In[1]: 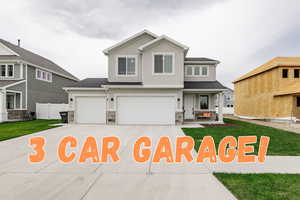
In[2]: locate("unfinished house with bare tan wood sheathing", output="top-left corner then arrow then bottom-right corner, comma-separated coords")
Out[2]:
233,57 -> 300,120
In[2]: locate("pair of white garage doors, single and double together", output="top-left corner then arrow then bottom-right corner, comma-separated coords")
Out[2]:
74,94 -> 177,125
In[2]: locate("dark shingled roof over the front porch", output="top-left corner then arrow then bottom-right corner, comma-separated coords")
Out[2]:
184,81 -> 227,89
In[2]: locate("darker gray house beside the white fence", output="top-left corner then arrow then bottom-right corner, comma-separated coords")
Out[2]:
0,39 -> 78,122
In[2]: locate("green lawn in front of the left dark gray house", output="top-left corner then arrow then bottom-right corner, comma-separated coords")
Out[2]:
0,120 -> 60,141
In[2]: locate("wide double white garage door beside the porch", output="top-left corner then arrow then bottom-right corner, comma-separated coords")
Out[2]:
117,96 -> 176,124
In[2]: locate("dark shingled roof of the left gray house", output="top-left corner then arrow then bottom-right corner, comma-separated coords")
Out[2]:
0,39 -> 78,80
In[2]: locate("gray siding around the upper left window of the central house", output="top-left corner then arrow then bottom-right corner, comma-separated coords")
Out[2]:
108,34 -> 153,82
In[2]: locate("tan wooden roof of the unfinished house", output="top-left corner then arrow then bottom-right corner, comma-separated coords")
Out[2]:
233,57 -> 300,83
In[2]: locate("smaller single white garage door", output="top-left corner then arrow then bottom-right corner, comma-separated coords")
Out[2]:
75,97 -> 106,124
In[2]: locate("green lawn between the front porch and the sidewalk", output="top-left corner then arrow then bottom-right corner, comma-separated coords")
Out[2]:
183,119 -> 300,156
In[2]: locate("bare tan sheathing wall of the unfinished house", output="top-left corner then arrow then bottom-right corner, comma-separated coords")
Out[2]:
234,67 -> 299,118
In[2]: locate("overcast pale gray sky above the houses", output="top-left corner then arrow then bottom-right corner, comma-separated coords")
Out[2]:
0,0 -> 300,87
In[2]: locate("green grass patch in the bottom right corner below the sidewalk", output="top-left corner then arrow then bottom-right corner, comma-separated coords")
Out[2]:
214,173 -> 300,200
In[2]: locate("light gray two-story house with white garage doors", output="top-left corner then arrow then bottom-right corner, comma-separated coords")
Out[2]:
65,30 -> 226,125
